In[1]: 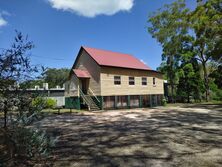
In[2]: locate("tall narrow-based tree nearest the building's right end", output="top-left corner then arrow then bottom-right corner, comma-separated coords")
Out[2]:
148,0 -> 189,101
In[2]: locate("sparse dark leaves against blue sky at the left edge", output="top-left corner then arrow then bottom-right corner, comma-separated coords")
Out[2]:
0,31 -> 38,89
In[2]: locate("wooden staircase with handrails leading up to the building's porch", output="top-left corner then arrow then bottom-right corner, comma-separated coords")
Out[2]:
79,89 -> 100,111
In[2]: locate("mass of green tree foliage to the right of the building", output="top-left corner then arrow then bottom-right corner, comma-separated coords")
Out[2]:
148,0 -> 222,101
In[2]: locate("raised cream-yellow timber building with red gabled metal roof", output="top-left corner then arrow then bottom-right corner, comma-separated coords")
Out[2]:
65,47 -> 164,110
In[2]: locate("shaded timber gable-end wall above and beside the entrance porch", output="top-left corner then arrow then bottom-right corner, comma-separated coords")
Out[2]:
75,50 -> 101,95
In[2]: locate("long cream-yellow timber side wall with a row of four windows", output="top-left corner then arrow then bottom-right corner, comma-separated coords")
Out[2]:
100,67 -> 164,96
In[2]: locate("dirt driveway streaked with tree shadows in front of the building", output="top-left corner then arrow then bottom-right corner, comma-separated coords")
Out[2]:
36,105 -> 222,167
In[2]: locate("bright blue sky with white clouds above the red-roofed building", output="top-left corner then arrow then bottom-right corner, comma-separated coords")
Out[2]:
0,0 -> 195,70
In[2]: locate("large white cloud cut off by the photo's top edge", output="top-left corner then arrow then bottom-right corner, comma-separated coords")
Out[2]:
48,0 -> 134,17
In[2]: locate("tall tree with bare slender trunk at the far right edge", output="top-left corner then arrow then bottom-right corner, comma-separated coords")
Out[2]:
187,0 -> 222,101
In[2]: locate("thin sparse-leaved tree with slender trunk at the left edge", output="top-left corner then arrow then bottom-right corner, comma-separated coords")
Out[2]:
0,31 -> 38,127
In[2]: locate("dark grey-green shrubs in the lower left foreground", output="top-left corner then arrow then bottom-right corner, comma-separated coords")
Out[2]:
0,95 -> 55,166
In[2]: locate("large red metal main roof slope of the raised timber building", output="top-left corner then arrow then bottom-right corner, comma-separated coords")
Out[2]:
83,47 -> 152,70
